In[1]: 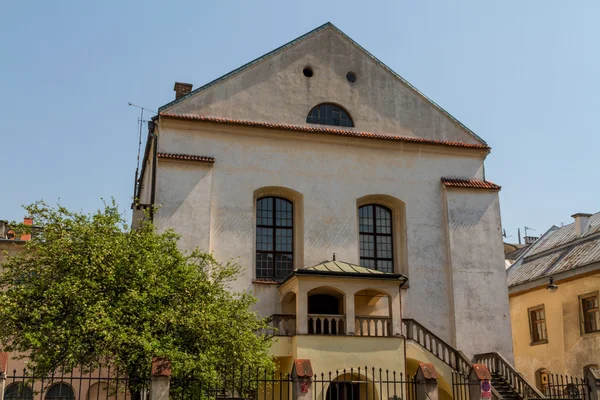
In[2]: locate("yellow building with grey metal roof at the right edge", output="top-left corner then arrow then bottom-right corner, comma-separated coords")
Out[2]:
507,213 -> 600,391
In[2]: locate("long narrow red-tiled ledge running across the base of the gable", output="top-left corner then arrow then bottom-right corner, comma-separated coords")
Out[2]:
159,113 -> 490,150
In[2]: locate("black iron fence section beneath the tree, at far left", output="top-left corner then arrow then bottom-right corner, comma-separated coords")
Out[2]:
4,365 -> 150,400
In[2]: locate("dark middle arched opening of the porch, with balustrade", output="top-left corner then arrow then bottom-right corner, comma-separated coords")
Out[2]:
307,286 -> 346,335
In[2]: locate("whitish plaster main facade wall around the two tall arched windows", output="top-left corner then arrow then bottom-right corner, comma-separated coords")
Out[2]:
156,120 -> 496,351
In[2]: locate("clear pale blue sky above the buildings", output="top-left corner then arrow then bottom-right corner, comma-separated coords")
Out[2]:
0,0 -> 600,241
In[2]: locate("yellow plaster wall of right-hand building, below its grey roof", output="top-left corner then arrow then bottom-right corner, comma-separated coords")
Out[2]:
510,273 -> 600,382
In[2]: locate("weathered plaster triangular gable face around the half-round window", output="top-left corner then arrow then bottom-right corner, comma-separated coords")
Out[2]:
159,22 -> 485,144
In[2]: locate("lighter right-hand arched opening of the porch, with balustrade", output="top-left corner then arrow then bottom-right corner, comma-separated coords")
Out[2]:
354,289 -> 392,336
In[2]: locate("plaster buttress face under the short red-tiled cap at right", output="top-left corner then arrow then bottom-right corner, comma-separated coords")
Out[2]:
442,188 -> 513,361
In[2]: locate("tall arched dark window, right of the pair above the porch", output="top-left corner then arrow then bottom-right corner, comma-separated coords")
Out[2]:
358,204 -> 394,272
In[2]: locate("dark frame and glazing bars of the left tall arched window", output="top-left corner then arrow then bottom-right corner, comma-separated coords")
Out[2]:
254,195 -> 296,281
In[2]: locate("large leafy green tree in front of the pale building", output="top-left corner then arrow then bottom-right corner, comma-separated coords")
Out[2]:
0,201 -> 272,390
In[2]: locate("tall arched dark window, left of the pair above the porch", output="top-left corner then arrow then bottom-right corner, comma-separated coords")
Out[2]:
256,197 -> 294,279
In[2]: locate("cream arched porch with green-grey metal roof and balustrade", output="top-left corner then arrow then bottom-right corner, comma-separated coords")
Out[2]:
279,260 -> 408,336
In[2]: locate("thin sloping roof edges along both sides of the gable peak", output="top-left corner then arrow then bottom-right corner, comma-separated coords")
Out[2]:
158,22 -> 487,147
